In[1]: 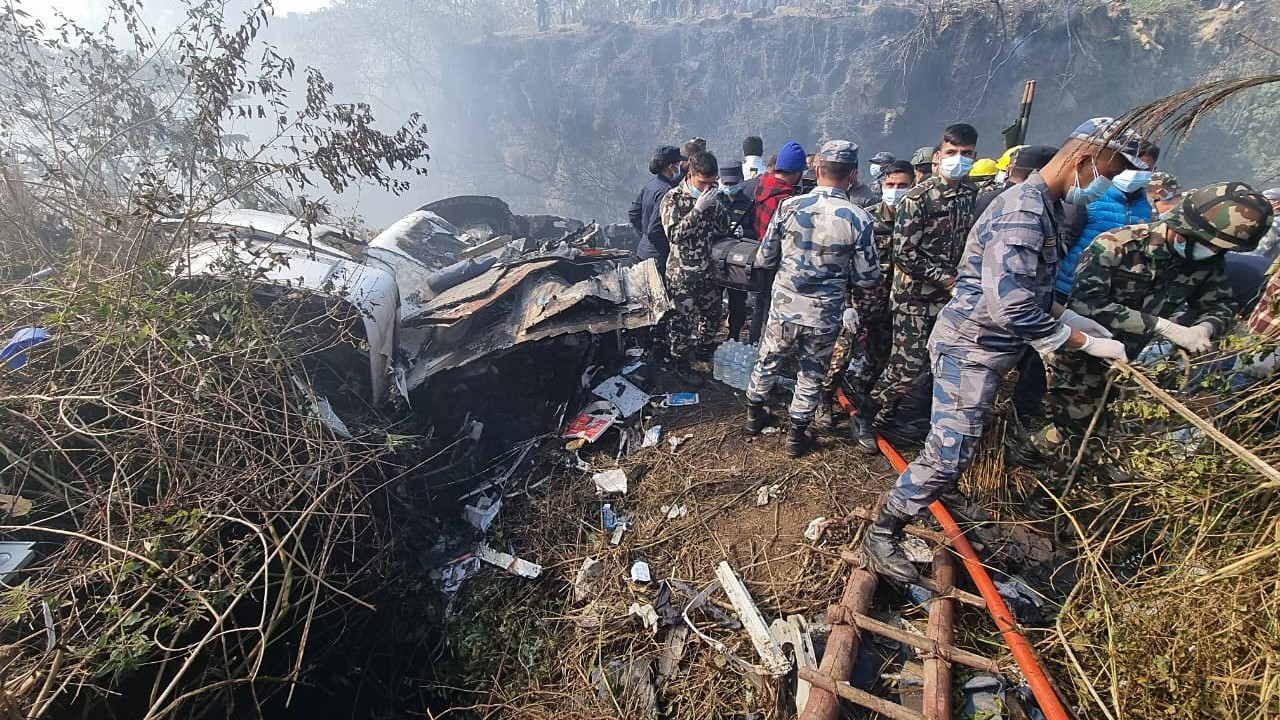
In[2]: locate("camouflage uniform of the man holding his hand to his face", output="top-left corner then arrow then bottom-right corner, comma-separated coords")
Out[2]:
659,183 -> 730,359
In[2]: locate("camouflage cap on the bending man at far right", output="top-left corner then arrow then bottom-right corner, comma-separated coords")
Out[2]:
1165,182 -> 1274,252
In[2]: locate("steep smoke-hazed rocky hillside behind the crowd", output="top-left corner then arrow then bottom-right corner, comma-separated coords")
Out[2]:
282,0 -> 1280,220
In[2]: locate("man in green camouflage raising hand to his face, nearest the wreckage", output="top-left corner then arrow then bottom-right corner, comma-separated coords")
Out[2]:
659,152 -> 730,384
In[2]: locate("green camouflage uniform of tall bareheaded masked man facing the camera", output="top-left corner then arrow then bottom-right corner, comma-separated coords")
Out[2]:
872,177 -> 977,425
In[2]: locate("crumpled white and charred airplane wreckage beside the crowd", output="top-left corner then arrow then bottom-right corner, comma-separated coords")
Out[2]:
163,196 -> 672,405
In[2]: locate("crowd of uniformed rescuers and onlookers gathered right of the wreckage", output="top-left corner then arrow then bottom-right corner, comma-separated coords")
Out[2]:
630,118 -> 1280,582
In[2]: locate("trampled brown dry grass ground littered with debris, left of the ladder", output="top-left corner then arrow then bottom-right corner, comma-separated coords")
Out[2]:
435,384 -> 893,719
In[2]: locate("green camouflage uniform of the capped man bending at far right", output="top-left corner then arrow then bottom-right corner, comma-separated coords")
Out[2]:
1032,222 -> 1236,475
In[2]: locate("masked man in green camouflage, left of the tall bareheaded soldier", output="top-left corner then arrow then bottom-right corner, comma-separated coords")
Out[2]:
815,160 -> 915,440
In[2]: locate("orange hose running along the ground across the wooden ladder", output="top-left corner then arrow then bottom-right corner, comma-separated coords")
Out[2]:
876,437 -> 1070,720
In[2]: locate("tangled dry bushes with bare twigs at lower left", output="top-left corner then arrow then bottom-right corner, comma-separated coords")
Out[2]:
0,242 -> 401,719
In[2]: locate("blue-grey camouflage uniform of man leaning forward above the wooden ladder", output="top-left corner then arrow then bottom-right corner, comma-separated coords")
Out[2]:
886,173 -> 1070,518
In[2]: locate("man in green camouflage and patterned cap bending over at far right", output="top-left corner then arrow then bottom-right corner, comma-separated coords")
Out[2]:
1032,182 -> 1272,479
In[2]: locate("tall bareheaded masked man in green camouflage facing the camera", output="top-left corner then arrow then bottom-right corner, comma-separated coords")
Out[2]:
864,123 -> 978,447
